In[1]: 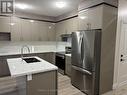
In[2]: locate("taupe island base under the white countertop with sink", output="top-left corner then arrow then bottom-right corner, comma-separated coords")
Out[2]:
16,71 -> 58,95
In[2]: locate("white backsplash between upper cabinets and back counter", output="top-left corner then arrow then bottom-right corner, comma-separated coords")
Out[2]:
0,42 -> 71,55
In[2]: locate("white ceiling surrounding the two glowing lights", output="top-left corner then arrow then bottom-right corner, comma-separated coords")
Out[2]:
15,0 -> 83,17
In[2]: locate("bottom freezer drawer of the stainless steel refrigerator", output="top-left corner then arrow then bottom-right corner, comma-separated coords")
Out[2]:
71,66 -> 94,95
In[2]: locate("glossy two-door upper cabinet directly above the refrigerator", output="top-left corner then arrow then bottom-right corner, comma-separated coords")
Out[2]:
78,6 -> 103,30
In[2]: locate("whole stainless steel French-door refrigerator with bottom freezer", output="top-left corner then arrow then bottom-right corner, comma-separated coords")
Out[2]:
71,29 -> 101,95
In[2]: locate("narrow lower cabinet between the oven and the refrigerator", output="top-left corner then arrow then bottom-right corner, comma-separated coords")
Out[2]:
65,56 -> 71,76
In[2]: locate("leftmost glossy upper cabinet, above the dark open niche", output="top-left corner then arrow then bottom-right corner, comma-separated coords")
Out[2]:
0,16 -> 11,32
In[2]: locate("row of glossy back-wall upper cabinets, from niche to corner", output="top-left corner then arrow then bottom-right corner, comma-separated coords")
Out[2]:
10,17 -> 56,41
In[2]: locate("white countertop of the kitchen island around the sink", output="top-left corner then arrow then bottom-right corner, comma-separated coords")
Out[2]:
7,56 -> 58,77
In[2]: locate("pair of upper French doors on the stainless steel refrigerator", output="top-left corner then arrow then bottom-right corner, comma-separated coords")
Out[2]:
72,30 -> 95,71
